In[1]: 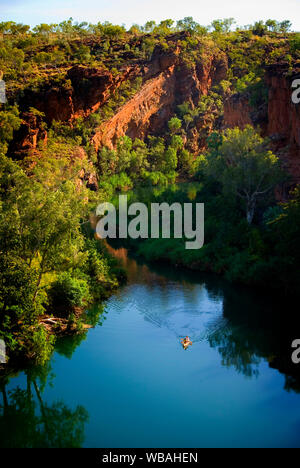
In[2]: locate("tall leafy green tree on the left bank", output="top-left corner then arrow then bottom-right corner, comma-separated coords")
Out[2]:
0,155 -> 88,359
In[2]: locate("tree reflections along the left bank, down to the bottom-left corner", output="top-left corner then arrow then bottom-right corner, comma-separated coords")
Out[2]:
0,300 -> 105,448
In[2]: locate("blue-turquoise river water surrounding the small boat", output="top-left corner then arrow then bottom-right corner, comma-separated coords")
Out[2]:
0,250 -> 300,448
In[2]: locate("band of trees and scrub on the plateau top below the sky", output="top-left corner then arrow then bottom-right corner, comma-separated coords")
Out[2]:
0,17 -> 299,100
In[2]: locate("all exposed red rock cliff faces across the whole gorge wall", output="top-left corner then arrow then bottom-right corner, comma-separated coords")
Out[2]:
11,41 -> 300,182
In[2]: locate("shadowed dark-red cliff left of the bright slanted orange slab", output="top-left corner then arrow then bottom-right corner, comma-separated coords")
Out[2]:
10,66 -> 140,158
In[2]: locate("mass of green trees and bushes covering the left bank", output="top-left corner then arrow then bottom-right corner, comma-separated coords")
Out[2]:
0,155 -> 125,362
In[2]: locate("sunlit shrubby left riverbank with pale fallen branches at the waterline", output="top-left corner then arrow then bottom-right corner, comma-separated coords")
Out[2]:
0,234 -> 126,374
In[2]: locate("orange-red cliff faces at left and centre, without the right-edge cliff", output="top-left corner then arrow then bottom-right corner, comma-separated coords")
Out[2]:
14,46 -> 227,152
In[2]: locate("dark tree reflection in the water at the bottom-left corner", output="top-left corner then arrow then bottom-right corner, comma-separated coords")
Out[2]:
0,369 -> 88,448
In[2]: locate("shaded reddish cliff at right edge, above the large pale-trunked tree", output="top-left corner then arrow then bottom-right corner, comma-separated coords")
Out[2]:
224,64 -> 300,183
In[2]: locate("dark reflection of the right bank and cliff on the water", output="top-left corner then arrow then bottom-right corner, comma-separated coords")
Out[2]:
107,245 -> 300,393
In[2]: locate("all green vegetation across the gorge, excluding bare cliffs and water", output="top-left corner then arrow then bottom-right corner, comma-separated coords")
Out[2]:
0,18 -> 300,368
